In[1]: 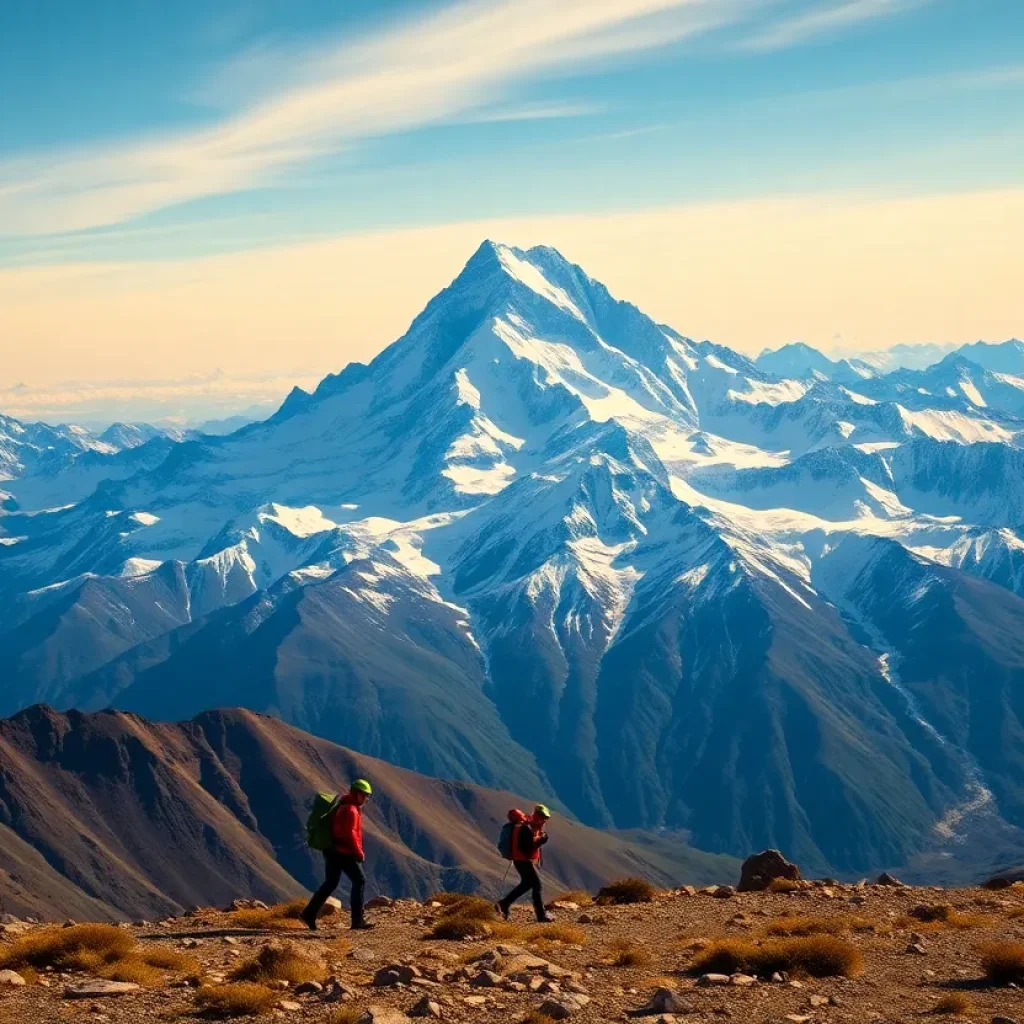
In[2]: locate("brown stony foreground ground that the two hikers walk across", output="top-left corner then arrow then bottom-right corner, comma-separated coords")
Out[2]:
0,883 -> 1024,1024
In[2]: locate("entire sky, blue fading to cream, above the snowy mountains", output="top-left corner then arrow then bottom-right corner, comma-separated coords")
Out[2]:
0,0 -> 1024,397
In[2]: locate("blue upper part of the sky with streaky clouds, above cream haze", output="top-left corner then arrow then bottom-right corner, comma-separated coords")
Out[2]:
0,0 -> 1024,265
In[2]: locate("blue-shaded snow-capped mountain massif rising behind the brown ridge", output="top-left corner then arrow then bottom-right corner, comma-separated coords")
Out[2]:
0,243 -> 1024,879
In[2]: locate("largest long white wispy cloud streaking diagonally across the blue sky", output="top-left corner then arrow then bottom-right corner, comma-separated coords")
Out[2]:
0,0 -> 942,238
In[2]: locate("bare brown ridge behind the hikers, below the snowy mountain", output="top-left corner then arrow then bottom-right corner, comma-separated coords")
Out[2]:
0,707 -> 738,921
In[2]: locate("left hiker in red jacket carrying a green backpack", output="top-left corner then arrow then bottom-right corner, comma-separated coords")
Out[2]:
299,778 -> 374,932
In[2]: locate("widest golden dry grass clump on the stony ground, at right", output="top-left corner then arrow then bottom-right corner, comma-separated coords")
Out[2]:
689,935 -> 863,978
